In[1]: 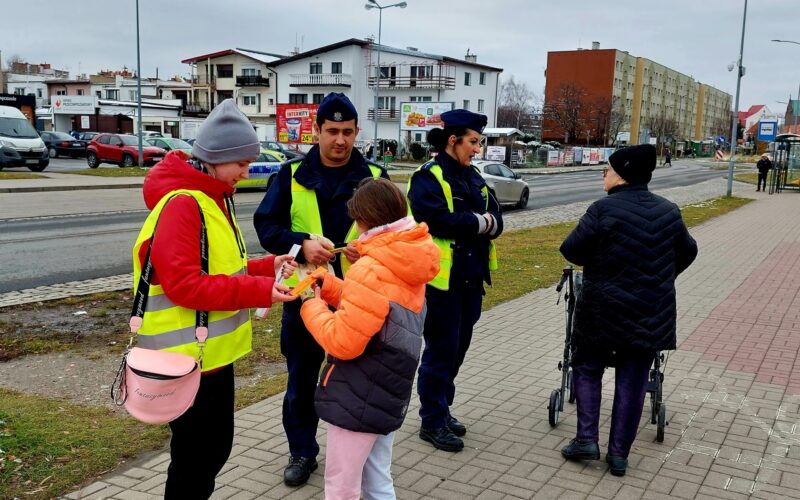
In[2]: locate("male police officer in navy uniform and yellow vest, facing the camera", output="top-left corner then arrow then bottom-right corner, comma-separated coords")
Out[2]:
253,93 -> 388,486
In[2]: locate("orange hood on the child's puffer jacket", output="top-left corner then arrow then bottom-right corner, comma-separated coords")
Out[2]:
355,222 -> 439,285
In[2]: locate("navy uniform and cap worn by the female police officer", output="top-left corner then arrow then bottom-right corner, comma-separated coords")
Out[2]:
408,110 -> 503,429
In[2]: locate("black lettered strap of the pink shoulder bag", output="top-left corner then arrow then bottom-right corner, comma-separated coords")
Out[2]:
128,194 -> 208,365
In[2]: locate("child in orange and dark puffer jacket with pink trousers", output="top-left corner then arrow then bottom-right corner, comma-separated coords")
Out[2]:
300,178 -> 439,500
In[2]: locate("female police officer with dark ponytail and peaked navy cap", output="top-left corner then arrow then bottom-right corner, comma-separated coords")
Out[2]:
408,109 -> 503,451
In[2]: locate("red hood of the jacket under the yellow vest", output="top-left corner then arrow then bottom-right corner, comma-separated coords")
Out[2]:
142,150 -> 234,210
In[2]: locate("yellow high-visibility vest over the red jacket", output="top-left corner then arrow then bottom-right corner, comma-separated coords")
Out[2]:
133,189 -> 253,371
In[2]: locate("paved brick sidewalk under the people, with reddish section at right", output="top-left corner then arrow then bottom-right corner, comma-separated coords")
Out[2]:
61,189 -> 800,499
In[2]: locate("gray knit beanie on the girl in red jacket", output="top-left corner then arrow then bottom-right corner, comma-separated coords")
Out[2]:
192,99 -> 261,165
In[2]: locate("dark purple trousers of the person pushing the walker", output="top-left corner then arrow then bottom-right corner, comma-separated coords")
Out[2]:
572,354 -> 654,458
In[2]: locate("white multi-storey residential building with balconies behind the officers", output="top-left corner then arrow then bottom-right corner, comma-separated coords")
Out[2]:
270,38 -> 503,142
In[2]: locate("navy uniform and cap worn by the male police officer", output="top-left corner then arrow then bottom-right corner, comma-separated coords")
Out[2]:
253,94 -> 388,458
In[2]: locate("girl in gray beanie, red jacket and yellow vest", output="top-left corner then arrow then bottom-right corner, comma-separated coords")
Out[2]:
133,99 -> 296,499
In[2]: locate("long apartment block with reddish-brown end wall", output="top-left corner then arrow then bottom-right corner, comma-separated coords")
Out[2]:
542,42 -> 732,144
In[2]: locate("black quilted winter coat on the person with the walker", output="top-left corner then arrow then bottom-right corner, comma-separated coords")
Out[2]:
561,184 -> 697,355
